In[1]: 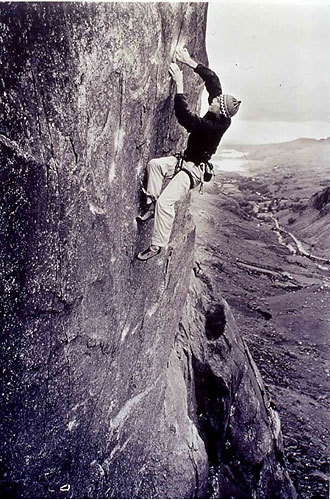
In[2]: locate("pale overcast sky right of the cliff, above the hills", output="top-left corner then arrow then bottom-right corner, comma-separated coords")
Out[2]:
203,0 -> 330,144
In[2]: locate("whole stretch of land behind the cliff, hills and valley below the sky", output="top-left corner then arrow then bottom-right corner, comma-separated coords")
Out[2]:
192,136 -> 330,498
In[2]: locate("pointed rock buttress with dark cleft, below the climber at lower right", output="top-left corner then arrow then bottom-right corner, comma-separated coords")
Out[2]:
177,274 -> 295,498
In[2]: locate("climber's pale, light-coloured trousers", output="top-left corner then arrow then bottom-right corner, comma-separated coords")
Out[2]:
147,156 -> 201,247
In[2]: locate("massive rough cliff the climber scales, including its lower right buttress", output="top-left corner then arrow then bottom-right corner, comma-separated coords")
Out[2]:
0,3 -> 293,498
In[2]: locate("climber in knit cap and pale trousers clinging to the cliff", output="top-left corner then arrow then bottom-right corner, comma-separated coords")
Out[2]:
137,48 -> 241,260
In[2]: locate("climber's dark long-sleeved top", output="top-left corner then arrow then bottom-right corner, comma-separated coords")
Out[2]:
174,64 -> 231,164
